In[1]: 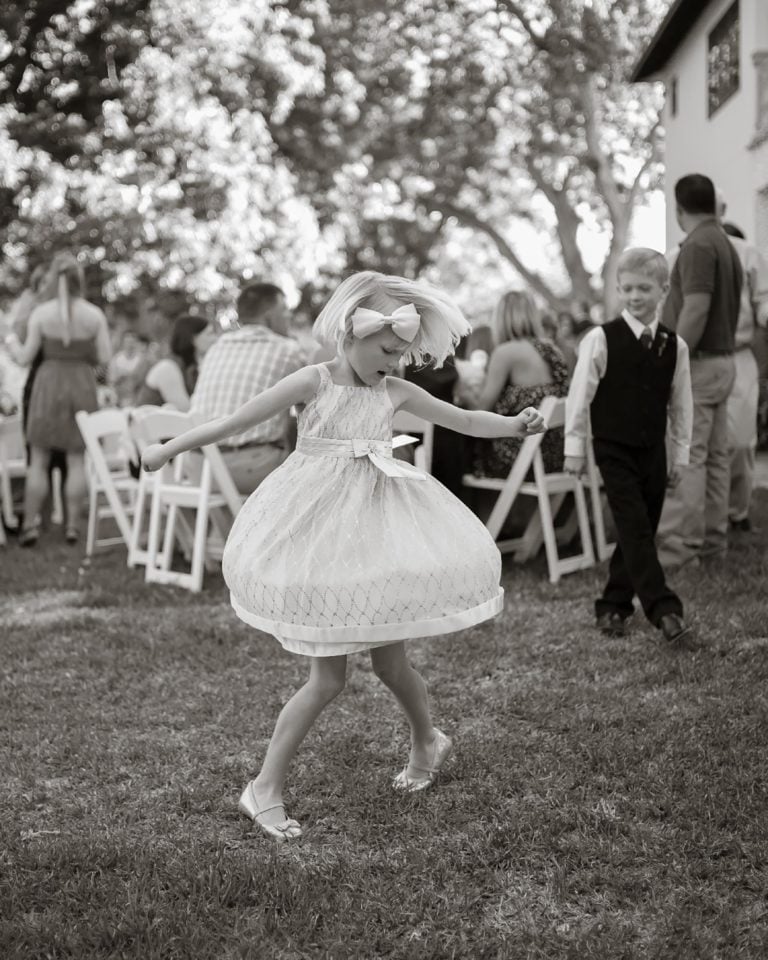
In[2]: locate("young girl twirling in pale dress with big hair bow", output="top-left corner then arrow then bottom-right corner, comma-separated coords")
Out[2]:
142,272 -> 544,840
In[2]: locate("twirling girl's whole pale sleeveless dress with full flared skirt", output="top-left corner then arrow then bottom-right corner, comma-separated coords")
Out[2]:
223,364 -> 503,657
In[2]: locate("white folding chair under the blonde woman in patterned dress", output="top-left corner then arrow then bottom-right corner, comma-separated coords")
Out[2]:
463,397 -> 595,583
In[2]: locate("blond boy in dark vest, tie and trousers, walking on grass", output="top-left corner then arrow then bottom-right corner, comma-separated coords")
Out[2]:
564,247 -> 693,647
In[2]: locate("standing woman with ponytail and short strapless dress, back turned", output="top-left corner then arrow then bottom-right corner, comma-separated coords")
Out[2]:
5,253 -> 112,546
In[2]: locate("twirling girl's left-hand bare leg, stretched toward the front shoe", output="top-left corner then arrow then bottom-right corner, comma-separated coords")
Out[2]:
253,656 -> 347,826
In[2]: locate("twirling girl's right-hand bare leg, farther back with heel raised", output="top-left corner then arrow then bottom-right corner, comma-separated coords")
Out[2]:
371,643 -> 435,777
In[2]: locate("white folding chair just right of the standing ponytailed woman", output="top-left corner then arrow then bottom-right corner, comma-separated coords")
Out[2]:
75,409 -> 138,556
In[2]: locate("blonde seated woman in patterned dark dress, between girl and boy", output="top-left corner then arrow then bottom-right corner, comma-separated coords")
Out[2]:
473,290 -> 568,477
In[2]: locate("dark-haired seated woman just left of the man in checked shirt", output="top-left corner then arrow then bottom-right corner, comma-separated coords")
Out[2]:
136,316 -> 216,413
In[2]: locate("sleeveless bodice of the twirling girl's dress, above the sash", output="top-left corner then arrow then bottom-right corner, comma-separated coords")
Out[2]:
298,363 -> 392,440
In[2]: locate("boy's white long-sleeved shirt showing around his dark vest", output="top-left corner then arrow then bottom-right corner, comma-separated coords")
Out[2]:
565,310 -> 693,467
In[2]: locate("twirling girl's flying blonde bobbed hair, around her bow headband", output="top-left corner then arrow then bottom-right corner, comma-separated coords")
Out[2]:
312,270 -> 472,367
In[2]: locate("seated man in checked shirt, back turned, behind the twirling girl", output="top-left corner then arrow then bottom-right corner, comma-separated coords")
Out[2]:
190,283 -> 304,495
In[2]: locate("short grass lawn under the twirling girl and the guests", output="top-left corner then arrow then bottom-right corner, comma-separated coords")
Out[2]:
0,491 -> 768,960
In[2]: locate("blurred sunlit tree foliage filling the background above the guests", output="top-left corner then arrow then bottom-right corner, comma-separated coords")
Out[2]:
0,0 -> 661,327
